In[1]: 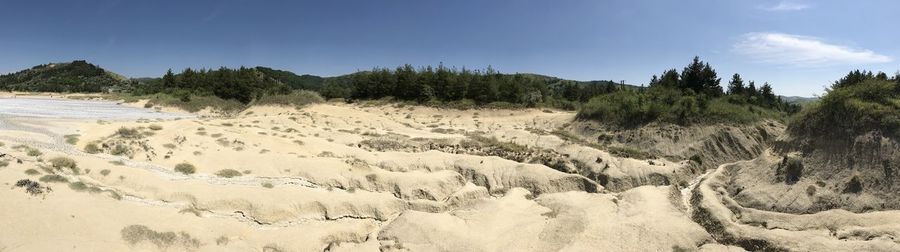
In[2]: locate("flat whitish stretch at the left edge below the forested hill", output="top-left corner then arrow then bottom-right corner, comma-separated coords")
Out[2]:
0,98 -> 192,120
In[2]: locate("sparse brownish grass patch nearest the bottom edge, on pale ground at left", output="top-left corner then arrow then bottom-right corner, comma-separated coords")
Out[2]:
121,225 -> 200,250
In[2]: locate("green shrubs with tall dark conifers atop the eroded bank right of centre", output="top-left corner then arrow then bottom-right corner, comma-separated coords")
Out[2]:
578,58 -> 800,128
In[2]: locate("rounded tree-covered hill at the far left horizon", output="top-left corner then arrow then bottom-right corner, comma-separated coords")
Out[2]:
0,60 -> 128,92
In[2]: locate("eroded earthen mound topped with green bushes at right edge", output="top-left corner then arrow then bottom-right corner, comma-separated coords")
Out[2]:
733,72 -> 900,213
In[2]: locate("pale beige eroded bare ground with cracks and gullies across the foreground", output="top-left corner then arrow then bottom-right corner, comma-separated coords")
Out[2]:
0,99 -> 896,251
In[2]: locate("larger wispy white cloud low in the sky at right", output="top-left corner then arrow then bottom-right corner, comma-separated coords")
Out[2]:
733,33 -> 894,67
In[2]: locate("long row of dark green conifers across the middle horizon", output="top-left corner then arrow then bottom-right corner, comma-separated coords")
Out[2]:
322,64 -> 622,108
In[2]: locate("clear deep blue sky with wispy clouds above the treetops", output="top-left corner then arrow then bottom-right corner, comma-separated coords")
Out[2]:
0,0 -> 900,96
